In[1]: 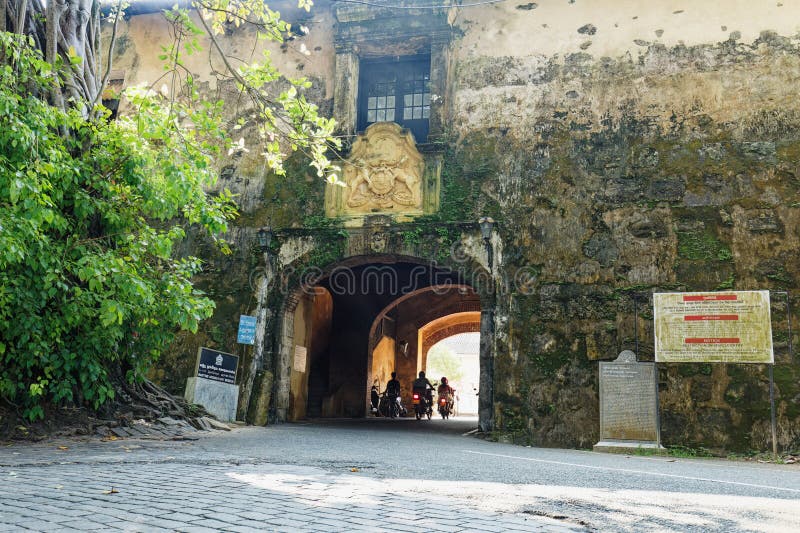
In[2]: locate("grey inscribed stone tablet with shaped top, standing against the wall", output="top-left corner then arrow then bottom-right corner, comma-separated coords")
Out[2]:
598,350 -> 659,447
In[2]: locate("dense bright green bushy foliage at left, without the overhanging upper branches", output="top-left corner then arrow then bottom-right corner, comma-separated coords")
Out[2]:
0,33 -> 235,419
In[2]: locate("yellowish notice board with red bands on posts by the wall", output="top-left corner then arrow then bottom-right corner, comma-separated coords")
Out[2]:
653,291 -> 775,363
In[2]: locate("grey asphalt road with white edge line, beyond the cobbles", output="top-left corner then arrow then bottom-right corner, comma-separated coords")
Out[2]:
0,419 -> 800,531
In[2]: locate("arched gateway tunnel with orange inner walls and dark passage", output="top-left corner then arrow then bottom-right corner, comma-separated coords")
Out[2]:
273,254 -> 493,426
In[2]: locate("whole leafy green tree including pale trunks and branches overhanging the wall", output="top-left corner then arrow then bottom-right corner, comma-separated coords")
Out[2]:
0,0 -> 339,419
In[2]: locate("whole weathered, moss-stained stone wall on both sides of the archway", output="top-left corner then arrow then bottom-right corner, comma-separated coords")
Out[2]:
111,0 -> 800,449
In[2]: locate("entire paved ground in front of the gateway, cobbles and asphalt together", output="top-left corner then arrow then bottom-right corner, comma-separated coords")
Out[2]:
0,420 -> 800,532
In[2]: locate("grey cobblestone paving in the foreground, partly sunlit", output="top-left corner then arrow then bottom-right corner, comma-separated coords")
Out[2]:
0,430 -> 584,532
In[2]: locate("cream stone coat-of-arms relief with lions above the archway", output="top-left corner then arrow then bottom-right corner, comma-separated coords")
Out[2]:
344,122 -> 425,210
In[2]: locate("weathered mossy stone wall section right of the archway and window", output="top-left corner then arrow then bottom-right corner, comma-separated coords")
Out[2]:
449,2 -> 800,449
